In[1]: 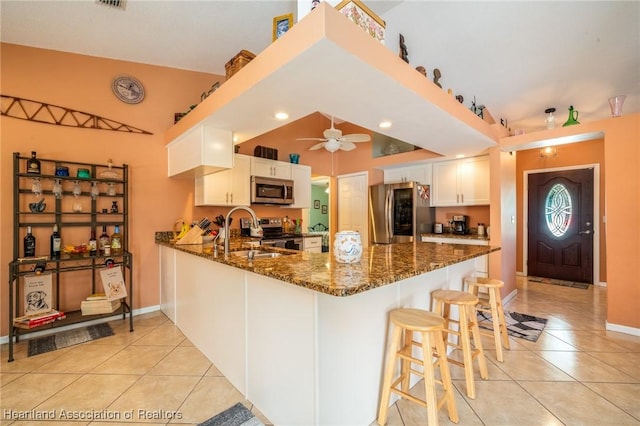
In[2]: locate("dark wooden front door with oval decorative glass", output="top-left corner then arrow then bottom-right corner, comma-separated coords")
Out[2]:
527,168 -> 594,283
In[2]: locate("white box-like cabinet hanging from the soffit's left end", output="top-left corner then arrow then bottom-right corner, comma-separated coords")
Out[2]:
167,121 -> 233,178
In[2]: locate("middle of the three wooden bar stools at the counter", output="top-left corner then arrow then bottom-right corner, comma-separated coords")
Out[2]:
431,290 -> 488,399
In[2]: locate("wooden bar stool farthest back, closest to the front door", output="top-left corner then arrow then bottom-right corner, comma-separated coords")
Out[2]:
464,277 -> 511,362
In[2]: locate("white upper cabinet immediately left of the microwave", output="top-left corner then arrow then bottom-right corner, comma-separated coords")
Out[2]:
195,154 -> 251,206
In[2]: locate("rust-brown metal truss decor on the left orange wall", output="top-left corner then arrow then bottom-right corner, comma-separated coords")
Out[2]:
0,95 -> 153,135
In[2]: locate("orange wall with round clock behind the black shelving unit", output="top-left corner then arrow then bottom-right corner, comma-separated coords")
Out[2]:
0,44 -> 220,335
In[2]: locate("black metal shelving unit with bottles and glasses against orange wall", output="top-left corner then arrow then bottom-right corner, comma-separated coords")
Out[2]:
8,152 -> 133,362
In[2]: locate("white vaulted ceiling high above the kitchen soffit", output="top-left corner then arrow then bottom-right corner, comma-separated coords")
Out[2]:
0,0 -> 640,135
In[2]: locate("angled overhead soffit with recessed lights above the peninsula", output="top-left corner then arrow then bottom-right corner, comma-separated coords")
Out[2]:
172,5 -> 497,156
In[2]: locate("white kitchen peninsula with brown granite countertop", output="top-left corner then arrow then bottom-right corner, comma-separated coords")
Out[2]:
159,241 -> 499,425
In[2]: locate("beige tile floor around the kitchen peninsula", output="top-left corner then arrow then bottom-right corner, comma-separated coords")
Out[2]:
0,278 -> 640,426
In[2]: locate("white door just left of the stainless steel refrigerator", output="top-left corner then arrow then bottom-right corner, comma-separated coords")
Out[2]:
338,173 -> 369,247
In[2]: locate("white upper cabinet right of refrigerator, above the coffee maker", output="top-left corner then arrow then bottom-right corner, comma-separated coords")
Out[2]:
431,156 -> 489,207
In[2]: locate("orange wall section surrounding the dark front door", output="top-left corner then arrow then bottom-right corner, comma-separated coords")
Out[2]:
516,139 -> 607,282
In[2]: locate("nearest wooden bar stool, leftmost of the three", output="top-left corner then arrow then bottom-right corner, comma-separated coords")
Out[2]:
378,308 -> 458,425
